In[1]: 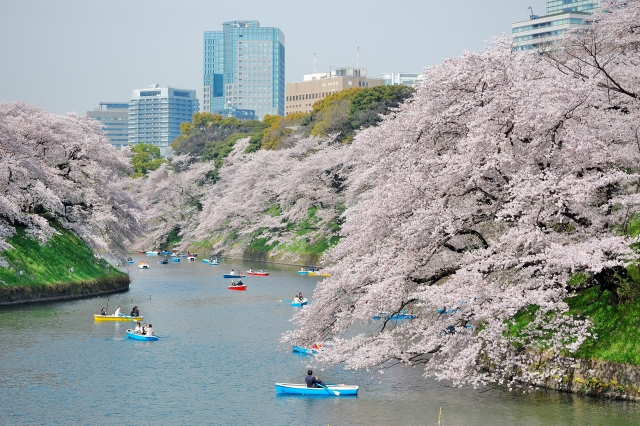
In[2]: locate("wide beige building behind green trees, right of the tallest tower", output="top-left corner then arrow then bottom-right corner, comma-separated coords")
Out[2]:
286,67 -> 384,114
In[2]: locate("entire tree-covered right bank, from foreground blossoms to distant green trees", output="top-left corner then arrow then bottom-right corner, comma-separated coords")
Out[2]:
130,0 -> 640,385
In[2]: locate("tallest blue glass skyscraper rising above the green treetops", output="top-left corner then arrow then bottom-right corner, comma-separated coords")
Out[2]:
202,21 -> 285,120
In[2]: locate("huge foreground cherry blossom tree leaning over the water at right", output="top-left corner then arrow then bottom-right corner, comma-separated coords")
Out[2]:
283,0 -> 640,385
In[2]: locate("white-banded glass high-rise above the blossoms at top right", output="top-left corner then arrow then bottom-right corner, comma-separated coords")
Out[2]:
511,0 -> 601,50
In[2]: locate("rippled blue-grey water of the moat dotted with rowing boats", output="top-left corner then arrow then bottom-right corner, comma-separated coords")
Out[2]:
0,256 -> 640,425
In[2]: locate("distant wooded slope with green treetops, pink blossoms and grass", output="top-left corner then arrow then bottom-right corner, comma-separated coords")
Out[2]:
132,86 -> 414,264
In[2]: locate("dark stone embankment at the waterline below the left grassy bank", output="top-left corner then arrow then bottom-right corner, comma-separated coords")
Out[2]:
0,274 -> 131,306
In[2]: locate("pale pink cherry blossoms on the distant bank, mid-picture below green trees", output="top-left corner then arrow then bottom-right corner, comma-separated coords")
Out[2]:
178,138 -> 348,261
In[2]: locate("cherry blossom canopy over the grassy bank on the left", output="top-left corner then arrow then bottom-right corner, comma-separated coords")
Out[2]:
0,102 -> 143,256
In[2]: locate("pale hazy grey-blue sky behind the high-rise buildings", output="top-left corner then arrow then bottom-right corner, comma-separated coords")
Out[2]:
0,0 -> 546,114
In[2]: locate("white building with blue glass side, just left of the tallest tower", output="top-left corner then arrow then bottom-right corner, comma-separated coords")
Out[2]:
129,84 -> 199,157
